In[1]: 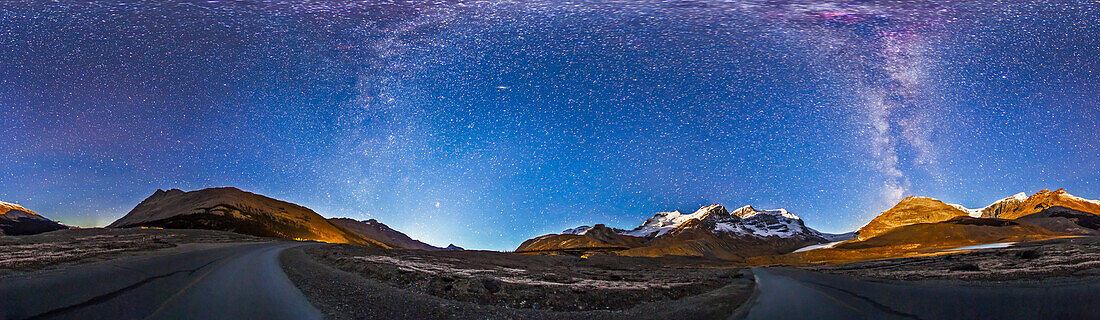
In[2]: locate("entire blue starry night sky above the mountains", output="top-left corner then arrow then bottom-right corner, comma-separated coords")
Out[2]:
0,0 -> 1100,250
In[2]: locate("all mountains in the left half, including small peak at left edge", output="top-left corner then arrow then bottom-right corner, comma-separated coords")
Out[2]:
0,187 -> 463,251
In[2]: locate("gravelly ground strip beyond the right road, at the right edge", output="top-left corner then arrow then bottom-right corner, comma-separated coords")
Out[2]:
804,236 -> 1100,282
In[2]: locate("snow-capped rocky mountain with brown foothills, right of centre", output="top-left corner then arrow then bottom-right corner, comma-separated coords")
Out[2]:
516,205 -> 833,261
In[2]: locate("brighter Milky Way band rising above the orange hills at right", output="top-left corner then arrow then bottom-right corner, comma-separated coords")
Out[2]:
756,2 -> 953,215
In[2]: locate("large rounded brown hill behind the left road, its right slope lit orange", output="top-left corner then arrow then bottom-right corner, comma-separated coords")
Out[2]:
108,188 -> 389,247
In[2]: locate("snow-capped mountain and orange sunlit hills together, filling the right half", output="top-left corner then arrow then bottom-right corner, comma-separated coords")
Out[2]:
516,189 -> 1100,264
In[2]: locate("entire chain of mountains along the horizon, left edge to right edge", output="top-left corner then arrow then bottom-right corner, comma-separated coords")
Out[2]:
0,188 -> 1100,264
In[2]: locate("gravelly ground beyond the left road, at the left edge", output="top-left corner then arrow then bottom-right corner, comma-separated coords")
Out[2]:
0,229 -> 268,276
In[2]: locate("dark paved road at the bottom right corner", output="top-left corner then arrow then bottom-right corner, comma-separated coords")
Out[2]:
747,268 -> 1100,320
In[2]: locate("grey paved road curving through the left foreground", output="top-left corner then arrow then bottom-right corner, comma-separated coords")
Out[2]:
0,242 -> 322,319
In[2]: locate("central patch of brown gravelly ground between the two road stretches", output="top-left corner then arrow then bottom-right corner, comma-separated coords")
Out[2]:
283,245 -> 754,319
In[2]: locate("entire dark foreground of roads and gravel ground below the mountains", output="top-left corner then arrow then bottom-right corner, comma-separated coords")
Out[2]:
0,229 -> 1100,319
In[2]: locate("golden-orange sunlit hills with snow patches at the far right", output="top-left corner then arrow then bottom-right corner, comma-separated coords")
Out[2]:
751,189 -> 1100,264
